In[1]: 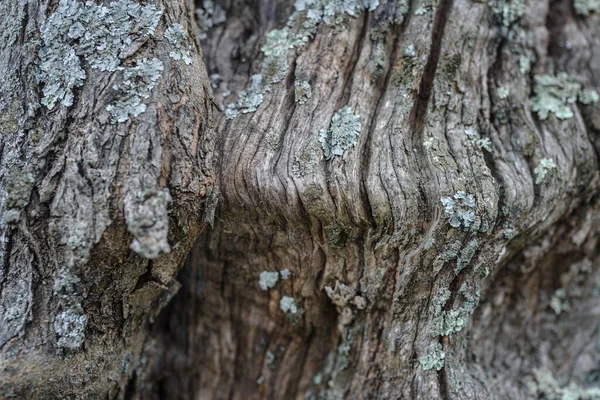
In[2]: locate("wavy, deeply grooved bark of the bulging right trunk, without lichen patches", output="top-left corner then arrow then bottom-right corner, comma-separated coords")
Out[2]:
148,0 -> 600,399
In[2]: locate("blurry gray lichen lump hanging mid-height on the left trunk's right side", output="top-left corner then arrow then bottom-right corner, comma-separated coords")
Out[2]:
125,189 -> 171,259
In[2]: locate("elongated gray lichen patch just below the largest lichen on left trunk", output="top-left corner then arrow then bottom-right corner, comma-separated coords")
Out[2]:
106,58 -> 163,122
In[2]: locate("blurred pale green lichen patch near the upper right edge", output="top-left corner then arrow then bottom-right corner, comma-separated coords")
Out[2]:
531,72 -> 600,120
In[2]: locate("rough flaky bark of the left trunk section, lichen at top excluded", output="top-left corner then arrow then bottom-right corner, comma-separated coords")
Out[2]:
0,0 -> 215,399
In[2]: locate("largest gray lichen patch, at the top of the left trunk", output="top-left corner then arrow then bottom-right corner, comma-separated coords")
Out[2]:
38,0 -> 162,109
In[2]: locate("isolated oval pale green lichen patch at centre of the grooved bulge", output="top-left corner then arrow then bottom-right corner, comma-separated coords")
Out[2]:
319,106 -> 361,160
